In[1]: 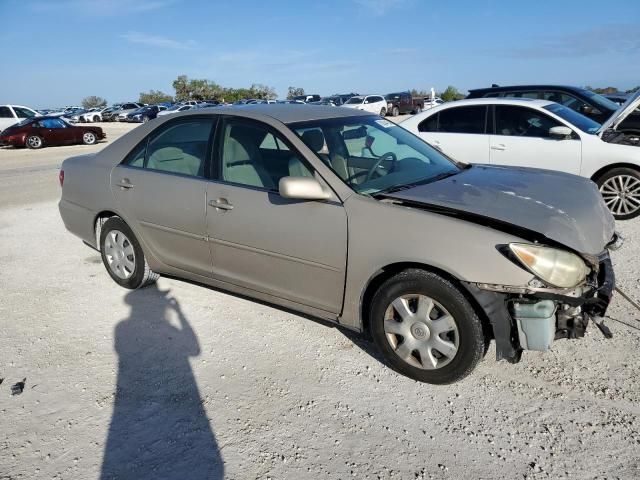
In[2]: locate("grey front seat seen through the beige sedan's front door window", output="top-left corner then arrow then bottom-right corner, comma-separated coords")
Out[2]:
222,126 -> 276,190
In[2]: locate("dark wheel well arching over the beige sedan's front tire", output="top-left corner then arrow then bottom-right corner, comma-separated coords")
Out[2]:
360,262 -> 493,338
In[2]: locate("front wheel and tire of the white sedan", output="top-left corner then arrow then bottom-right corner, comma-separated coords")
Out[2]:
596,167 -> 640,220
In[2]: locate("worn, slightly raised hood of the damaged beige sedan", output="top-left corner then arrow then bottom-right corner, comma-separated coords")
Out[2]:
386,165 -> 615,256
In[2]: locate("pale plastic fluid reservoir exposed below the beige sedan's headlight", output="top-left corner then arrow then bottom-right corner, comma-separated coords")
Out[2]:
512,300 -> 556,352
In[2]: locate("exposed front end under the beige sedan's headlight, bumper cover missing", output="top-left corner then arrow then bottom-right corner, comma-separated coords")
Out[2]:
464,251 -> 615,362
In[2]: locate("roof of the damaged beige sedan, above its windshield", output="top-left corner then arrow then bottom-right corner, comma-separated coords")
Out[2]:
177,103 -> 372,123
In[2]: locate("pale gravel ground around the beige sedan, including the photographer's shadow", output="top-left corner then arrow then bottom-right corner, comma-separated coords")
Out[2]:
0,117 -> 640,479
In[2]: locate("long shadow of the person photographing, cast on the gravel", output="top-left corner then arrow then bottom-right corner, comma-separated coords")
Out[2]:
100,285 -> 224,480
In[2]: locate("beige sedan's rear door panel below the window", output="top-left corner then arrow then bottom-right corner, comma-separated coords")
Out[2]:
111,165 -> 211,276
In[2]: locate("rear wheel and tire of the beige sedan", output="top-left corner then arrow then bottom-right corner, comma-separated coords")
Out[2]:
100,217 -> 160,290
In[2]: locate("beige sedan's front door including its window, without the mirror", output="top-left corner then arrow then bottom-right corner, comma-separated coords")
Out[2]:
206,119 -> 347,314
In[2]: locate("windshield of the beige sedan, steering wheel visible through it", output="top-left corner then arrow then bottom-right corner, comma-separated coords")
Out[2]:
290,116 -> 461,195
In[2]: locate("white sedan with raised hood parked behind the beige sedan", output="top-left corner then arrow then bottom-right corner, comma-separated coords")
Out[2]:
400,92 -> 640,220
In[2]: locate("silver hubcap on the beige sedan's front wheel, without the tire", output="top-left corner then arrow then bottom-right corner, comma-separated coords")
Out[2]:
384,294 -> 460,370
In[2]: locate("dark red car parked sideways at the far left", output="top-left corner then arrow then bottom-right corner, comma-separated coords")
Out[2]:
0,117 -> 106,148
